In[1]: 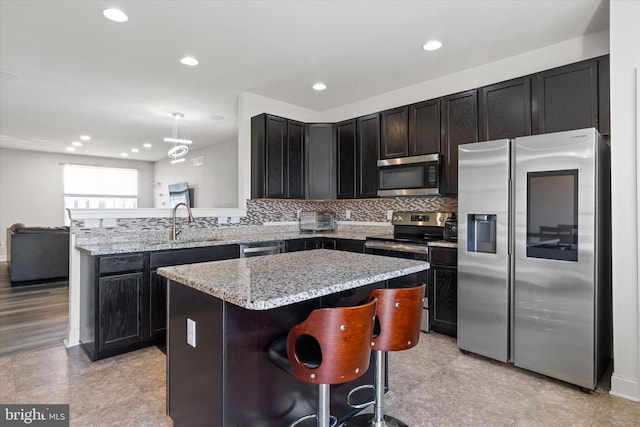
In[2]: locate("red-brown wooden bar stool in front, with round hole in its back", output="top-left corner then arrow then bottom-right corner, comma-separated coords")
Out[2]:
269,298 -> 377,427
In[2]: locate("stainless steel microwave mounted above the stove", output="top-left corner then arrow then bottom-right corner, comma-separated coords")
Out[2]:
378,154 -> 442,197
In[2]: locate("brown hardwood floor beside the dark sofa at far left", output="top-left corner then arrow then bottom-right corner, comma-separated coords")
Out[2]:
0,262 -> 69,356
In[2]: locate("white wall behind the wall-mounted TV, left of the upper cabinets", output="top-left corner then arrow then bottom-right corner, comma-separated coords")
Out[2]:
153,140 -> 238,208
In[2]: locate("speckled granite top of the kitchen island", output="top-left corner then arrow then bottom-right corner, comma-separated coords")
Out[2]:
158,249 -> 429,310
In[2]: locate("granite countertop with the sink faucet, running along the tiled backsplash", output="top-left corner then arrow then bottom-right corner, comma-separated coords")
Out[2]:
75,231 -> 380,256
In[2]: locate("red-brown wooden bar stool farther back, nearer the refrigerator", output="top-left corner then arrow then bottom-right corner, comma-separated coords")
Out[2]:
344,284 -> 426,427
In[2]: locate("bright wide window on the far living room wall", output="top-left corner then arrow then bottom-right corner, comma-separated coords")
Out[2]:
64,165 -> 138,209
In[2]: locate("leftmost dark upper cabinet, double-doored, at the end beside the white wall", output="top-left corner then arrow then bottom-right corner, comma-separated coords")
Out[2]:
251,114 -> 304,198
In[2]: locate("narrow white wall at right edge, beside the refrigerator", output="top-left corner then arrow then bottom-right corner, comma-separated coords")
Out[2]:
609,0 -> 640,401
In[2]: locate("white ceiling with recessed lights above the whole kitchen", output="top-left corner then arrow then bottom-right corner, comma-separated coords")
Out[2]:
0,0 -> 609,161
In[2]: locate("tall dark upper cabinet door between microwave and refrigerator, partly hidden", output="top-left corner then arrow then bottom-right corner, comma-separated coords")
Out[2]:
442,93 -> 478,194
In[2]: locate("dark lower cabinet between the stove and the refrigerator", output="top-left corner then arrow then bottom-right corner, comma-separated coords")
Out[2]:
427,247 -> 458,337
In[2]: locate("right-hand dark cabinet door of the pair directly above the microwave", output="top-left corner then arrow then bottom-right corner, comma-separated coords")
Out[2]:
409,99 -> 440,156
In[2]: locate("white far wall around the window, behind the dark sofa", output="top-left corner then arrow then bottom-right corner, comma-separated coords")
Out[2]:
0,148 -> 153,261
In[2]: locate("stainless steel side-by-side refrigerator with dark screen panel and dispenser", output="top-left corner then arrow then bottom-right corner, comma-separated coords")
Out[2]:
457,128 -> 612,389
